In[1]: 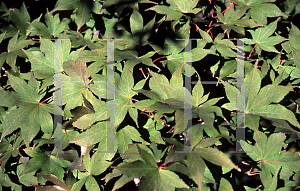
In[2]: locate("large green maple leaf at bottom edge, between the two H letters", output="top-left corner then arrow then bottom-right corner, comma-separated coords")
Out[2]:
115,145 -> 189,191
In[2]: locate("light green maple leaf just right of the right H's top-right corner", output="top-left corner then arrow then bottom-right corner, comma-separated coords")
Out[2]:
245,19 -> 286,54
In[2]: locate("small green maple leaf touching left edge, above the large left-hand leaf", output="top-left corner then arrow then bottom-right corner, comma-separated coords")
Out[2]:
0,31 -> 34,72
